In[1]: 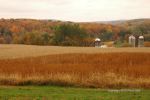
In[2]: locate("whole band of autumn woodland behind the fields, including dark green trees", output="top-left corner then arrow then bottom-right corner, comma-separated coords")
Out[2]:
0,19 -> 150,46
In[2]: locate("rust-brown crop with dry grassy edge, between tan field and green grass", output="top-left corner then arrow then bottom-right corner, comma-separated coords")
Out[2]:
0,52 -> 150,88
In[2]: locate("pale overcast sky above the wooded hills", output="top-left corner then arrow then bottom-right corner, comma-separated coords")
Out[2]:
0,0 -> 150,22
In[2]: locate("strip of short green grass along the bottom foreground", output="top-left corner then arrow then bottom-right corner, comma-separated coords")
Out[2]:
0,86 -> 150,100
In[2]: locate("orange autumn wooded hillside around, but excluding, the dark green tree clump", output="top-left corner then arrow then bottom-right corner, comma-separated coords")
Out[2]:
0,19 -> 150,45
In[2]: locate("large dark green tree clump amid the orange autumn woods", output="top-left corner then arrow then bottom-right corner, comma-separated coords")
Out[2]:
53,24 -> 87,46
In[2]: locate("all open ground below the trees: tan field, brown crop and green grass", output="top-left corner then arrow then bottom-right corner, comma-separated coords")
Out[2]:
0,45 -> 150,100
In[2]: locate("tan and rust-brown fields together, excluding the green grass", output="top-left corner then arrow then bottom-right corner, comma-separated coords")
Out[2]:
0,45 -> 150,88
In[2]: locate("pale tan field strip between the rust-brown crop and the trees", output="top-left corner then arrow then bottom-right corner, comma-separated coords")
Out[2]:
0,44 -> 150,59
